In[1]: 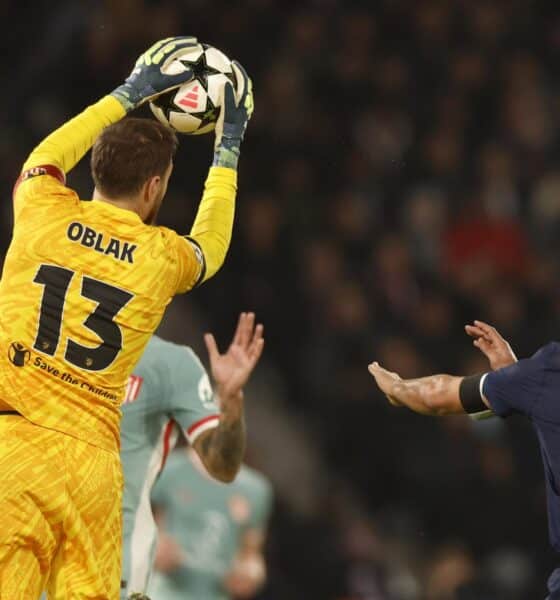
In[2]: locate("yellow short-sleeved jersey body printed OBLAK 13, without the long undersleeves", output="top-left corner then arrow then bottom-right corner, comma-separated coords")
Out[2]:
0,175 -> 202,449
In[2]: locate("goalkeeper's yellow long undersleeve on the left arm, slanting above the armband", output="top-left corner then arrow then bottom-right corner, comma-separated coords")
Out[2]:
22,96 -> 126,175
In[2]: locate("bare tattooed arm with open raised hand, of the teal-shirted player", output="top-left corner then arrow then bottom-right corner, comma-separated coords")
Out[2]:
194,313 -> 264,482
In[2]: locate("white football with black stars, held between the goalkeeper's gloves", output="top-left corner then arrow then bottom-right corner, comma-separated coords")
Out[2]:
150,44 -> 237,135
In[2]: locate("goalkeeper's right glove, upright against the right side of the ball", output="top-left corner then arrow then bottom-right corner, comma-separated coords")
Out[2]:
214,61 -> 255,169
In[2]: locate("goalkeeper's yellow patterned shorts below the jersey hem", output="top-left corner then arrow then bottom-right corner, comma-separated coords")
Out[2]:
0,416 -> 122,600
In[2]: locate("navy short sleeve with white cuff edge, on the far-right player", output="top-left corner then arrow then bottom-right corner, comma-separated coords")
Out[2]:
481,344 -> 558,417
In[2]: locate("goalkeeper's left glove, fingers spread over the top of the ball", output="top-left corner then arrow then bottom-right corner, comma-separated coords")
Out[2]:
111,36 -> 197,112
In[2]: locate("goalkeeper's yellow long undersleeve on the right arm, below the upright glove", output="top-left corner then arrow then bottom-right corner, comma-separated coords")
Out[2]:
188,167 -> 237,284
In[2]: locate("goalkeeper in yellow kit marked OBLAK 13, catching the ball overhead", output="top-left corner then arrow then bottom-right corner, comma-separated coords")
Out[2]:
0,37 -> 252,600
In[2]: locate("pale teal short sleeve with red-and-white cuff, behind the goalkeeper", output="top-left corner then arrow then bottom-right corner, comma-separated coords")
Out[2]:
164,346 -> 220,444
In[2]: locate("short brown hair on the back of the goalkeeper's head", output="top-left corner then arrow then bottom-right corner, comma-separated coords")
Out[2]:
91,117 -> 178,198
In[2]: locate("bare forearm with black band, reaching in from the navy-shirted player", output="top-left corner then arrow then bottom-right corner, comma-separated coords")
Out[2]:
368,362 -> 487,416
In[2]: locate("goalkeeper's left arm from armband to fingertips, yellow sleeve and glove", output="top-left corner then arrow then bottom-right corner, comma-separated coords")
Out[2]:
18,37 -> 196,181
